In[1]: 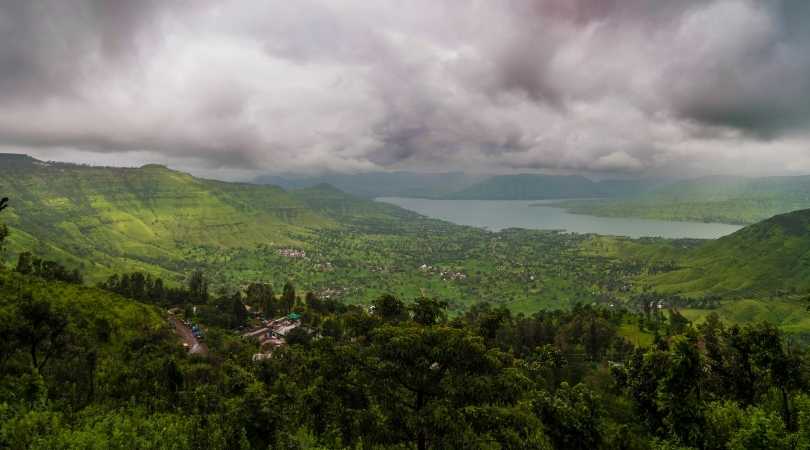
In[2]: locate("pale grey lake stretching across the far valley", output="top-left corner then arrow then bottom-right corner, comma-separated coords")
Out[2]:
377,197 -> 742,239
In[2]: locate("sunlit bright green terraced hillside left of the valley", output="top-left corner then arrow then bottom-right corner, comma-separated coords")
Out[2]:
0,157 -> 334,278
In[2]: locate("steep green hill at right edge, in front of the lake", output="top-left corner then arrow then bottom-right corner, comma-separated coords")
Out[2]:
652,209 -> 810,298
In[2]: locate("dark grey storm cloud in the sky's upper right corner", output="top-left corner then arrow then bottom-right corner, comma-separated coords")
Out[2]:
669,1 -> 810,137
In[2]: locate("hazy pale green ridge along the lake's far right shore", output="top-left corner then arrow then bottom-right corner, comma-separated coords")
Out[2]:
563,176 -> 810,225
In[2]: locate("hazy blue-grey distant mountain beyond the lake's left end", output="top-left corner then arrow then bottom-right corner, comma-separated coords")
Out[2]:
254,172 -> 483,198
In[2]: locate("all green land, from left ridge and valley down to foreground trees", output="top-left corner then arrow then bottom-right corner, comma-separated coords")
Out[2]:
6,159 -> 810,450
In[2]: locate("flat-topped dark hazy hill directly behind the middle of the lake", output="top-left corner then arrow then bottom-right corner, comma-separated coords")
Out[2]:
436,174 -> 654,200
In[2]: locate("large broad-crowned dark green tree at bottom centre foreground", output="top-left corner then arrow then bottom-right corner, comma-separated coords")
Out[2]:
358,325 -> 531,450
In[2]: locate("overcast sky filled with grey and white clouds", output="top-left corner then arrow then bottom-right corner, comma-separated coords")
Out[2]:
0,0 -> 810,176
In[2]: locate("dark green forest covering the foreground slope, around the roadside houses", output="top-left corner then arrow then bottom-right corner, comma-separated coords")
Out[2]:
0,210 -> 810,450
